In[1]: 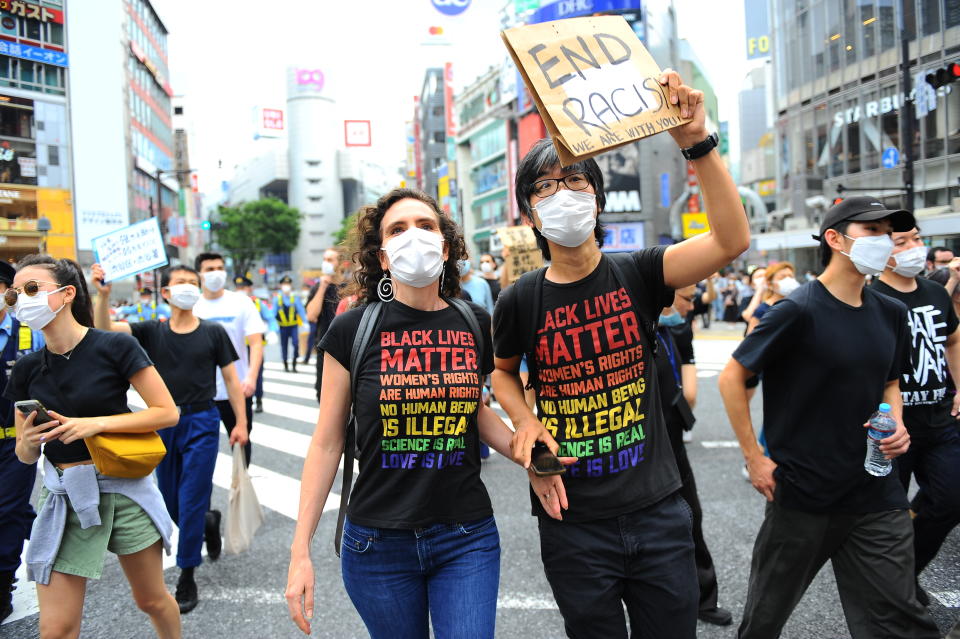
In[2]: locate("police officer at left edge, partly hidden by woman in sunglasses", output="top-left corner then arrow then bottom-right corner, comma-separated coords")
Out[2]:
0,260 -> 44,621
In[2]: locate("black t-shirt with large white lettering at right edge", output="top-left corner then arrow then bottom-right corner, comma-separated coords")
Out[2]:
872,278 -> 960,432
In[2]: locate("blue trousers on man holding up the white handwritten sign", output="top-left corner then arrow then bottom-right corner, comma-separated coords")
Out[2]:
157,404 -> 220,568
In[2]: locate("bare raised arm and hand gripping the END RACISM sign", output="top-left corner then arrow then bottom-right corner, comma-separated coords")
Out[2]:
660,69 -> 750,288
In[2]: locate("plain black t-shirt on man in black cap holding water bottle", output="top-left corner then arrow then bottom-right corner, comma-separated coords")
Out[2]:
733,280 -> 910,513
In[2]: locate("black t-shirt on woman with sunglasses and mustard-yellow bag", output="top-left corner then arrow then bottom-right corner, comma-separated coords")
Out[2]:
3,328 -> 153,464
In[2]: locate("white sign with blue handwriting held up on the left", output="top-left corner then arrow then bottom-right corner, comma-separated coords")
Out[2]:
93,217 -> 167,282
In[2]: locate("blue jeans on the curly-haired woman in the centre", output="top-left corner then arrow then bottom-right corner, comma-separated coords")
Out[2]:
340,517 -> 500,639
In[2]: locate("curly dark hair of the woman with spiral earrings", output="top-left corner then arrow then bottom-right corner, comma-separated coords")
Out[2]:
344,189 -> 467,305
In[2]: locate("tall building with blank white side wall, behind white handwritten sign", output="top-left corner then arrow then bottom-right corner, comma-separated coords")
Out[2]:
67,0 -> 180,274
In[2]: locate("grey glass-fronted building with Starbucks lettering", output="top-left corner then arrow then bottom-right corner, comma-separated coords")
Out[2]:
754,0 -> 960,269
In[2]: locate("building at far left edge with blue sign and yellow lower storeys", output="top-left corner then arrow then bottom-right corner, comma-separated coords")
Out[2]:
0,0 -> 76,261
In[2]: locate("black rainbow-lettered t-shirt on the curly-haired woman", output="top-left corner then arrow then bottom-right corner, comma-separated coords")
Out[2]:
320,300 -> 493,528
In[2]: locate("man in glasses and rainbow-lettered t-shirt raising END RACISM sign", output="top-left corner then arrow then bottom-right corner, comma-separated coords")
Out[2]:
493,71 -> 750,639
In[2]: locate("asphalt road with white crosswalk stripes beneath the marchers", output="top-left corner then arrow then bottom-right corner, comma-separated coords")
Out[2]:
0,329 -> 960,639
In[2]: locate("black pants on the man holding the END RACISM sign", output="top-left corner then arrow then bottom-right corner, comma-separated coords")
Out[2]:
539,494 -> 698,639
